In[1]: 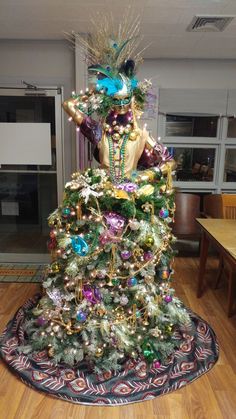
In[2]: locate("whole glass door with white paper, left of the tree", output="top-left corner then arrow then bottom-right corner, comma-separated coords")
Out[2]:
0,88 -> 64,263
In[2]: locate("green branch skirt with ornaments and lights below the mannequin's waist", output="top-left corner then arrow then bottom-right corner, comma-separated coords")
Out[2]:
22,165 -> 189,371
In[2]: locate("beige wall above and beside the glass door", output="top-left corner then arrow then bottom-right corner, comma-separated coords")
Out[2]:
0,40 -> 75,180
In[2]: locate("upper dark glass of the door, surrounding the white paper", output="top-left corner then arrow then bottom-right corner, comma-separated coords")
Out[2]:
0,96 -> 56,171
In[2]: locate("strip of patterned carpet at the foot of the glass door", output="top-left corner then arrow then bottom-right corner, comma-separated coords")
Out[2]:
0,263 -> 45,282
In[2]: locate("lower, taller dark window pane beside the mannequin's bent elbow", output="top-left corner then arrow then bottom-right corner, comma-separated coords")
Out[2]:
169,147 -> 216,182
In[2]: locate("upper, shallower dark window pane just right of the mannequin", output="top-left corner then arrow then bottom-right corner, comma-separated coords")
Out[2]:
166,115 -> 218,137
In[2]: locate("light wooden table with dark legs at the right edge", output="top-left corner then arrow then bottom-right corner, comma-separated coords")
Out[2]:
196,218 -> 236,316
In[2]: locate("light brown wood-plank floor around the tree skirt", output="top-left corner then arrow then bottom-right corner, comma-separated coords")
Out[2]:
0,257 -> 236,419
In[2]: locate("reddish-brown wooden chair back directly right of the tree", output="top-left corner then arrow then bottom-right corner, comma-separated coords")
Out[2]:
172,192 -> 200,239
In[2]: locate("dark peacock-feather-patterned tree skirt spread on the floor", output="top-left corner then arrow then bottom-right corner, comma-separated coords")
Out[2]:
0,296 -> 219,406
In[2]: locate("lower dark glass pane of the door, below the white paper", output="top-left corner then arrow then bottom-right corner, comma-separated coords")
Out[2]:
0,173 -> 57,253
